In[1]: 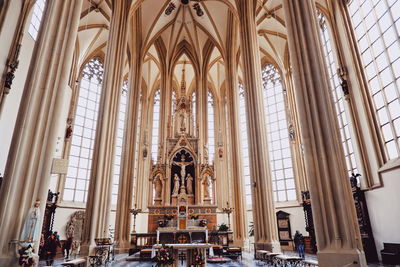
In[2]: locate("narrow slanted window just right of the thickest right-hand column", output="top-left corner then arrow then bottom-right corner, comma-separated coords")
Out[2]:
317,10 -> 358,175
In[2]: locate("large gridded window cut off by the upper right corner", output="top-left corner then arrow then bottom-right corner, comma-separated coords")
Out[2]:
348,0 -> 400,159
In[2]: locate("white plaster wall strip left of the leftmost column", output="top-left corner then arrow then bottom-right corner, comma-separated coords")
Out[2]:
0,23 -> 35,174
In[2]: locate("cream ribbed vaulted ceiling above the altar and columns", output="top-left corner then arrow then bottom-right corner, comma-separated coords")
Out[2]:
77,0 -> 329,98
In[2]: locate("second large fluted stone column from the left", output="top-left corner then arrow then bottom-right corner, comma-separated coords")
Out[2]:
81,0 -> 130,255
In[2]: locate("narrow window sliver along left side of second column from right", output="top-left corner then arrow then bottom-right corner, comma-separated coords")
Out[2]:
239,84 -> 252,205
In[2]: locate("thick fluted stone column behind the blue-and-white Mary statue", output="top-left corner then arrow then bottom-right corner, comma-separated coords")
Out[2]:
0,0 -> 82,266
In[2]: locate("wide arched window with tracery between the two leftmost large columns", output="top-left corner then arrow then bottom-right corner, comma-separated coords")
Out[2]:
63,58 -> 103,202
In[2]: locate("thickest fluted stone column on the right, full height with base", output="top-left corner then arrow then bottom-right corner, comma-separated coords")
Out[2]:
284,0 -> 367,267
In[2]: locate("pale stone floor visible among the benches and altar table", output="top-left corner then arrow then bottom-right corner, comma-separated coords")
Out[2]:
39,251 -> 400,267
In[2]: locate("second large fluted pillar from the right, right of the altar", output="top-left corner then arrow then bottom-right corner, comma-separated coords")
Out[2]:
237,0 -> 280,251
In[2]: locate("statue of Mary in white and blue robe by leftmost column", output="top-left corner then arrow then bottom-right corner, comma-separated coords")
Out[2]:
20,200 -> 40,243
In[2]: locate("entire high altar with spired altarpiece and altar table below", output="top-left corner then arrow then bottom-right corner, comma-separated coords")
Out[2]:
148,69 -> 217,262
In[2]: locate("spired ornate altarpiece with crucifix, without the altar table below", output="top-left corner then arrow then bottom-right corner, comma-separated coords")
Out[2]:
148,74 -> 217,232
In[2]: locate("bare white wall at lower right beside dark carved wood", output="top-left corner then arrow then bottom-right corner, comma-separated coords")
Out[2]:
366,167 -> 400,257
